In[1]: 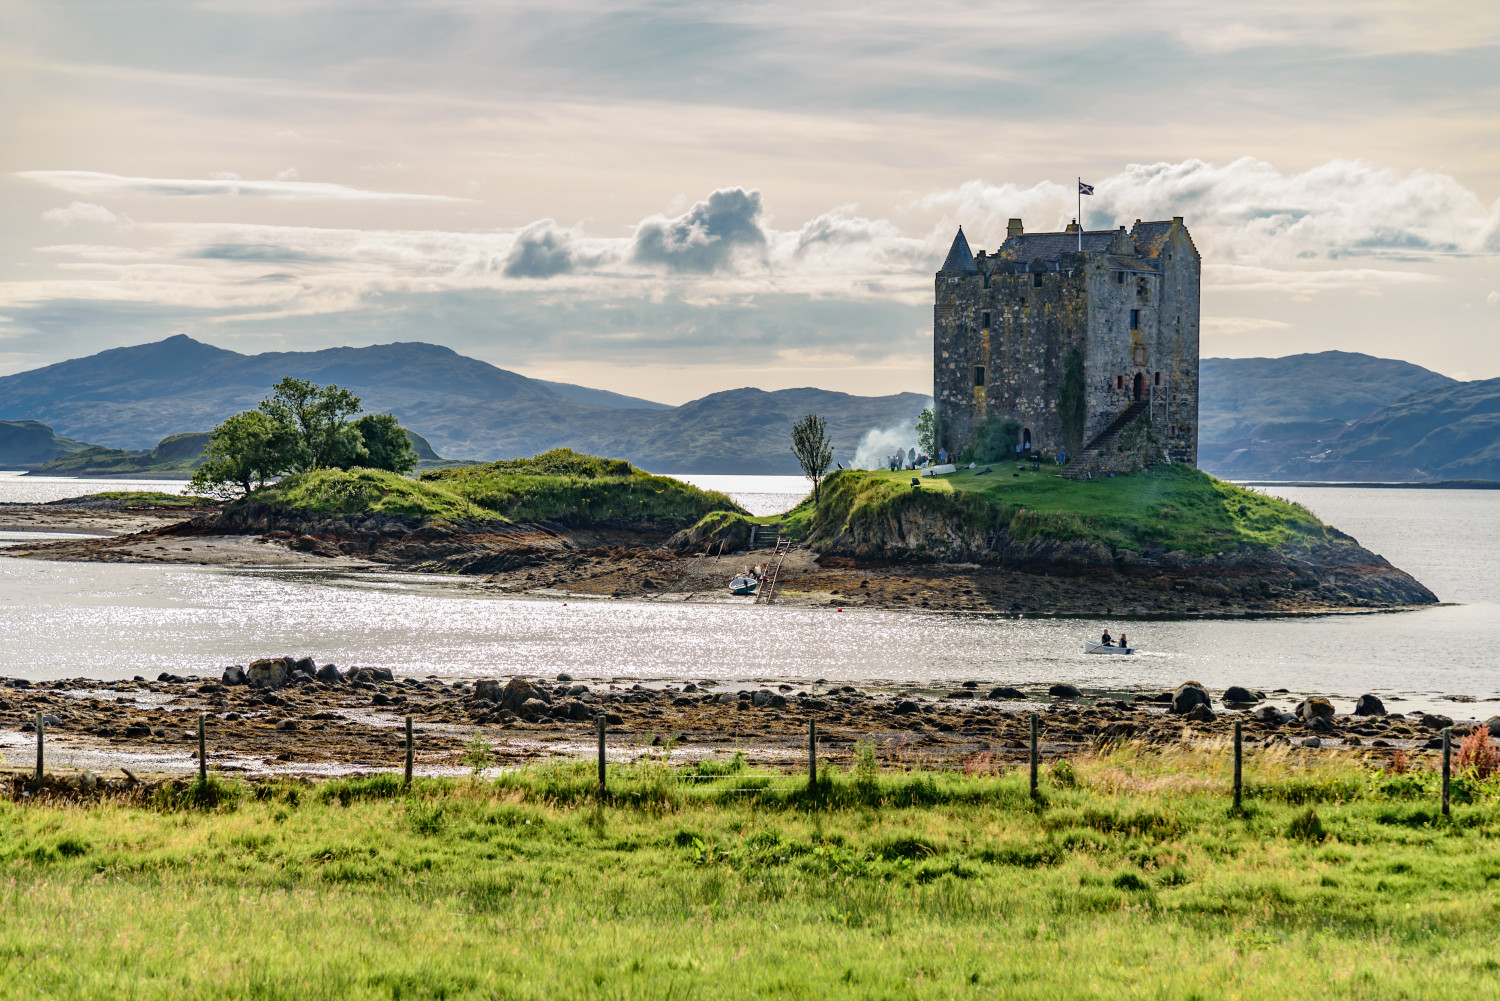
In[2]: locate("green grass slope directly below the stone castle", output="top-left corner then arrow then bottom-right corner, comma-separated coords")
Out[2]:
785,462 -> 1344,554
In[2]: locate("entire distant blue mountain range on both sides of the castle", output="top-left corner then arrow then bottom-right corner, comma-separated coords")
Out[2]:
0,336 -> 1500,480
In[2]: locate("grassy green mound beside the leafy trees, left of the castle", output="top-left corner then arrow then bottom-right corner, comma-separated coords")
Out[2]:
239,449 -> 743,530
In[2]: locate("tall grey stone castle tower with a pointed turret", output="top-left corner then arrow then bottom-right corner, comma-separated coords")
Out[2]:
933,216 -> 1200,477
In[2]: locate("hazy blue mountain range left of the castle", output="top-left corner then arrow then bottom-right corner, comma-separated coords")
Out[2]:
0,335 -> 927,474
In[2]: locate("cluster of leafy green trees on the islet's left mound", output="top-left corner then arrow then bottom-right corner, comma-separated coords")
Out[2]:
192,377 -> 417,497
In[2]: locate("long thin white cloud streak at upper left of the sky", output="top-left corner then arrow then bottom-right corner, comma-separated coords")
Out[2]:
17,170 -> 468,203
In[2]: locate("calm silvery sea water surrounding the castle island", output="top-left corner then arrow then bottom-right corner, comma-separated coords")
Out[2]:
0,477 -> 1500,717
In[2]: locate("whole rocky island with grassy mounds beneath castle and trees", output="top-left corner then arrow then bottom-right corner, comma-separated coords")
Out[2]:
0,449 -> 1437,617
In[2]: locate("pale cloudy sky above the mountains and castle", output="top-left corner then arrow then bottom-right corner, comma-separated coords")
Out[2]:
0,0 -> 1500,402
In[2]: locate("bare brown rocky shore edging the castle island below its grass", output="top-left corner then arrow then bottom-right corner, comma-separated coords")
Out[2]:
0,504 -> 1437,618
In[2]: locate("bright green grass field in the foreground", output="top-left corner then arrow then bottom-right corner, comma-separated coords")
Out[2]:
0,750 -> 1500,1001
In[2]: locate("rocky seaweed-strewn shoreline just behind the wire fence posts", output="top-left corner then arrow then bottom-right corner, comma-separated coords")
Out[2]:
0,656 -> 1500,774
